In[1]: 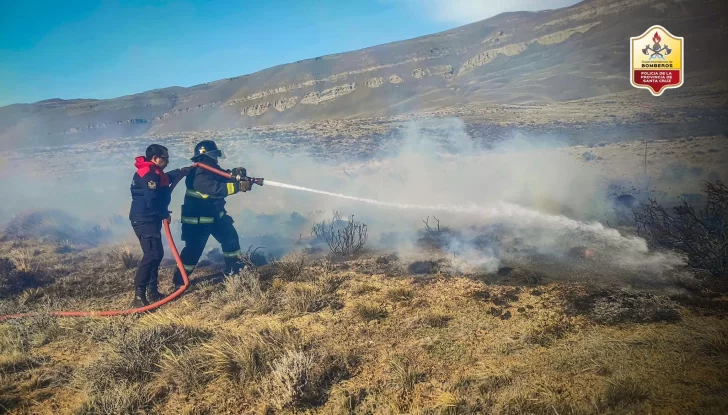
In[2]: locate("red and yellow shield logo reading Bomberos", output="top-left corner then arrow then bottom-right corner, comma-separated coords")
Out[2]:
629,26 -> 685,97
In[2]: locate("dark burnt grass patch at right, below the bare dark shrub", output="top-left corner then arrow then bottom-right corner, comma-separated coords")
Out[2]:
566,289 -> 682,324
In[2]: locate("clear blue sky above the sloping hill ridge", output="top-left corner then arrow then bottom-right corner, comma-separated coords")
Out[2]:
0,0 -> 576,106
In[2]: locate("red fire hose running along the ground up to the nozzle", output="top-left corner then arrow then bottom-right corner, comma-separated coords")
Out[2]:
0,163 -> 232,321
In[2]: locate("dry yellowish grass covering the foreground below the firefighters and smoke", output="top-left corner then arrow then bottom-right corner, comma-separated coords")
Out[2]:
0,236 -> 728,414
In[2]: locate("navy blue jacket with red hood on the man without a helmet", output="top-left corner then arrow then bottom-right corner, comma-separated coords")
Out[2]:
129,156 -> 182,222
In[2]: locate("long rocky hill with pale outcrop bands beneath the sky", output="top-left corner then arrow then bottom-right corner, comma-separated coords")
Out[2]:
0,0 -> 728,149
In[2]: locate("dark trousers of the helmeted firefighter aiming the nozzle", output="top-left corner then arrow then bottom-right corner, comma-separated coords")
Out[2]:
173,215 -> 242,285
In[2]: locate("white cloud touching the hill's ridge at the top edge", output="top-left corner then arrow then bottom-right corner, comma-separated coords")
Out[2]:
394,0 -> 578,25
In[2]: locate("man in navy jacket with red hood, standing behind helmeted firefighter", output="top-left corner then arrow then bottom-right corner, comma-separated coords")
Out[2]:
129,144 -> 190,308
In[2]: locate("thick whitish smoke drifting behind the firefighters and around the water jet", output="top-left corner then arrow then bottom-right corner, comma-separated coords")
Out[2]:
0,119 -> 682,280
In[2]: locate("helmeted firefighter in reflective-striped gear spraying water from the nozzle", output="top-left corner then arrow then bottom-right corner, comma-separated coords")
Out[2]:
173,140 -> 262,290
